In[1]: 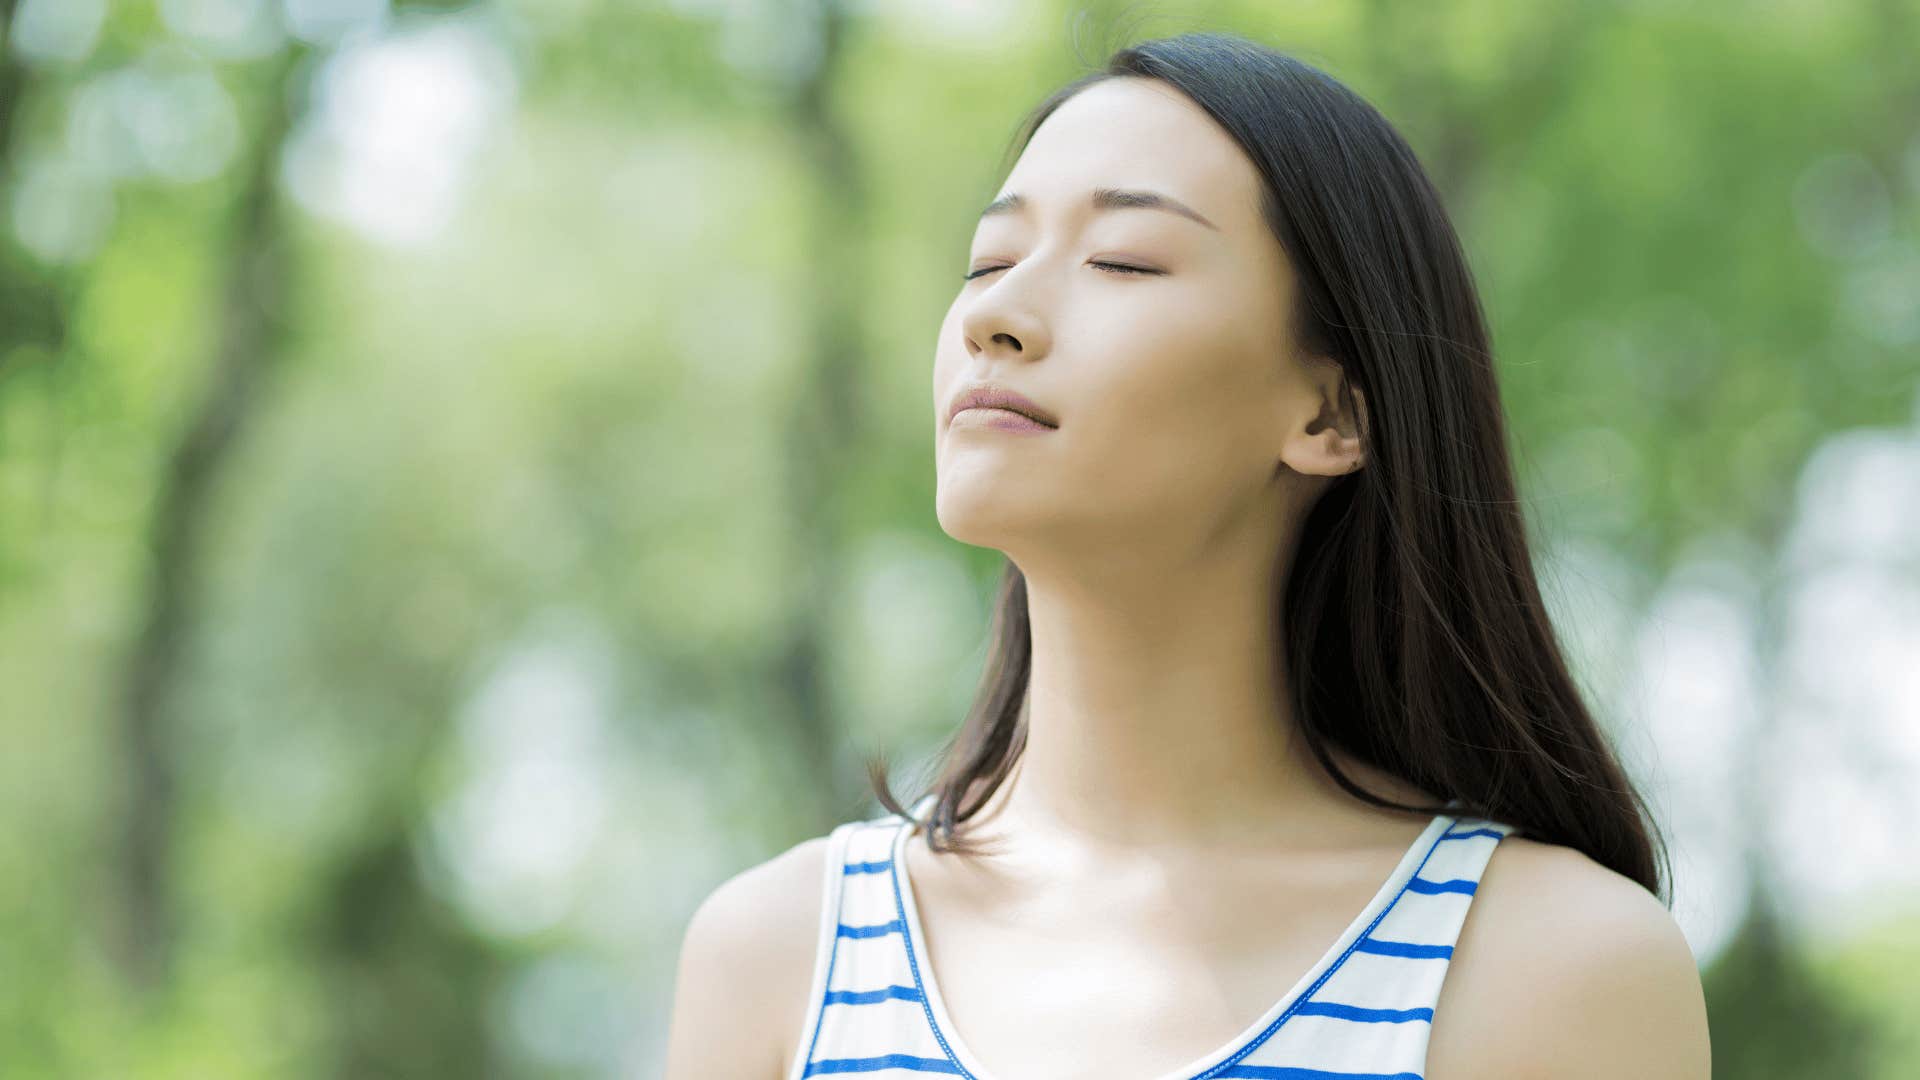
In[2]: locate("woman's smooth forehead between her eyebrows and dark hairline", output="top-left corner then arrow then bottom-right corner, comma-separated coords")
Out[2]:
1000,79 -> 1260,234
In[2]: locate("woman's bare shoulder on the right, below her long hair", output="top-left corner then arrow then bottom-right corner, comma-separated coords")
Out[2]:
1425,836 -> 1711,1080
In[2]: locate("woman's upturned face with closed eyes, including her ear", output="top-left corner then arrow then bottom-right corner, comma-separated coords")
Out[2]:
933,79 -> 1357,569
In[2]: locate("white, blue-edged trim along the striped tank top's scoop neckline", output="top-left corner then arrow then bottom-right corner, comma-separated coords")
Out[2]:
889,796 -> 1457,1080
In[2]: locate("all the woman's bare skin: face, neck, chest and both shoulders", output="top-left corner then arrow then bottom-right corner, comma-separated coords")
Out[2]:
666,79 -> 1711,1080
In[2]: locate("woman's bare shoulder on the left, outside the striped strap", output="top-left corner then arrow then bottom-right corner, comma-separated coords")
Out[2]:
666,836 -> 828,1080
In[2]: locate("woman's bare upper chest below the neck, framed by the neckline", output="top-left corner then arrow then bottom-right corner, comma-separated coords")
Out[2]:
914,849 -> 1405,1080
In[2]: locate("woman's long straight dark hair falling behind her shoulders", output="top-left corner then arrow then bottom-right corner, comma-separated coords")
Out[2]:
868,33 -> 1670,903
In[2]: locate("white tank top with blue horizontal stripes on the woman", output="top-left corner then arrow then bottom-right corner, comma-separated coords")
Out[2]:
787,794 -> 1519,1080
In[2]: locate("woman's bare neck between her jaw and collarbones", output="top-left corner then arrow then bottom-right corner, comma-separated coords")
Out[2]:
960,538 -> 1348,855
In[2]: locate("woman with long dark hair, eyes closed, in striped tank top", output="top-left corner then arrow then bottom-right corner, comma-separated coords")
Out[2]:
668,33 -> 1709,1080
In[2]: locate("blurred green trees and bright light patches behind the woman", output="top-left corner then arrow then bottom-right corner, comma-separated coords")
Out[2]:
0,0 -> 1920,1078
